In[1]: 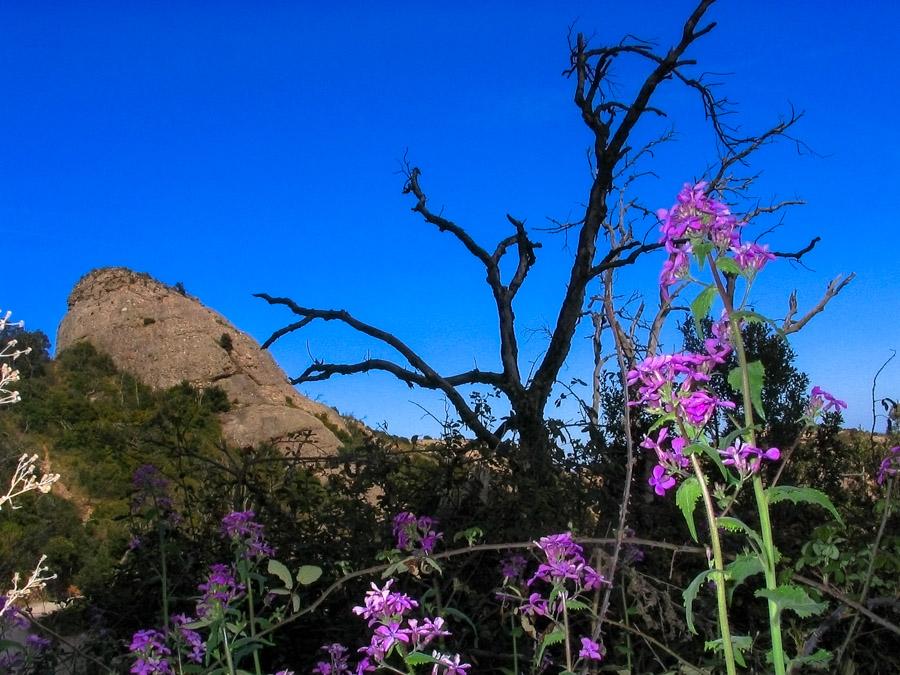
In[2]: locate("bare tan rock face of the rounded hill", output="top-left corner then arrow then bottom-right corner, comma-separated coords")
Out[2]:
56,267 -> 347,456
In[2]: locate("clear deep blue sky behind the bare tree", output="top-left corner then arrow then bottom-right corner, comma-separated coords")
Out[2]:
0,0 -> 900,434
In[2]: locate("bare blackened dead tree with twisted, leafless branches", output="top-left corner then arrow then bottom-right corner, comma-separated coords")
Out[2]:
258,0 -> 798,475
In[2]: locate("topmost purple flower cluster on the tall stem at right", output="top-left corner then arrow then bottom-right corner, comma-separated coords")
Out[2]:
656,182 -> 775,299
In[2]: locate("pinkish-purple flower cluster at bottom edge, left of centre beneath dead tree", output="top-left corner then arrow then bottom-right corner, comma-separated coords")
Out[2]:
350,579 -> 470,675
